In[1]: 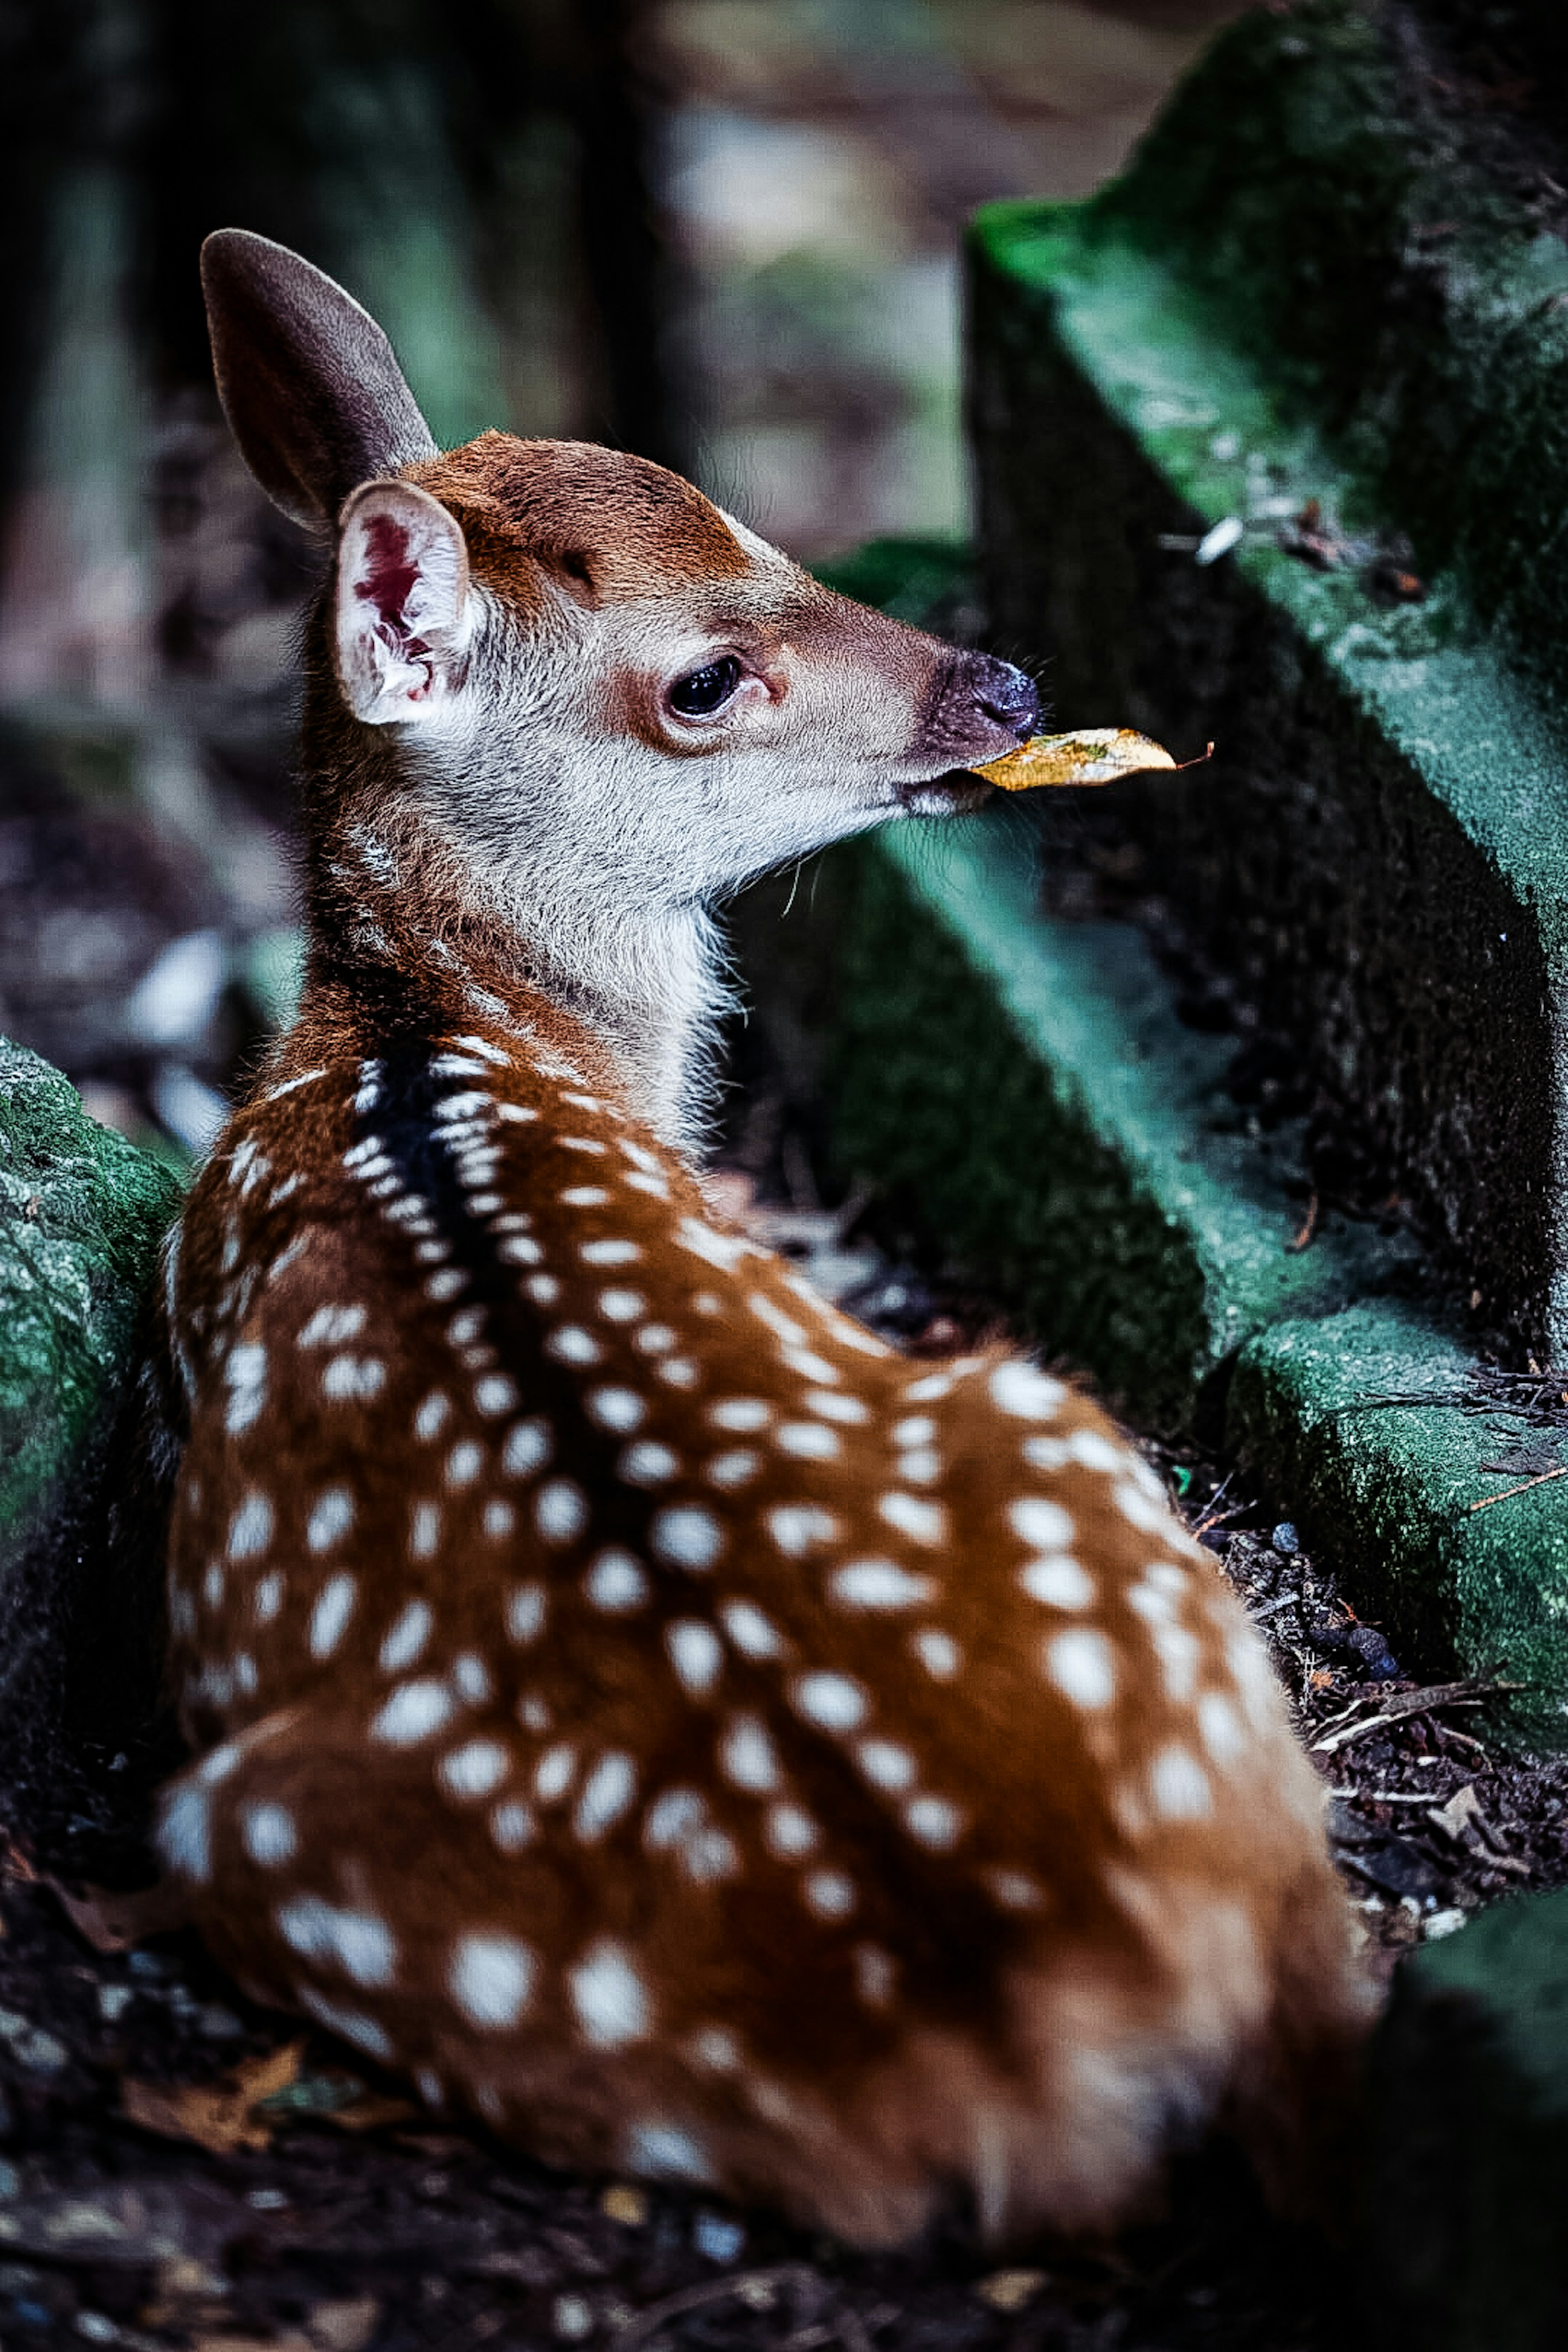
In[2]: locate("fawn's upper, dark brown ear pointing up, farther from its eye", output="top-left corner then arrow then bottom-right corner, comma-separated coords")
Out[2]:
202,228 -> 437,529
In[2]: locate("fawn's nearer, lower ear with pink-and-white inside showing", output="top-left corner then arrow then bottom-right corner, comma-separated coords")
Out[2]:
336,482 -> 472,727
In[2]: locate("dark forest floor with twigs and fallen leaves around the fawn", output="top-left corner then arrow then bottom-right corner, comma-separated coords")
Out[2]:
0,1169 -> 1568,2352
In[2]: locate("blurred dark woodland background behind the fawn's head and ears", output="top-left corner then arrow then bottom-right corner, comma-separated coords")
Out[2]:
0,0 -> 1241,1162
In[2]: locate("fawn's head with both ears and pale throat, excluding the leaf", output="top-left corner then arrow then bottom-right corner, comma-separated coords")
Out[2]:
202,228 -> 1039,1138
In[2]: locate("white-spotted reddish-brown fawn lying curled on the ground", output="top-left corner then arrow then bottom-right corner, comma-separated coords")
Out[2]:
158,230 -> 1361,2244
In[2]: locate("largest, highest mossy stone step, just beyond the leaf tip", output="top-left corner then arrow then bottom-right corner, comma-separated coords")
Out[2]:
971,0 -> 1568,1355
